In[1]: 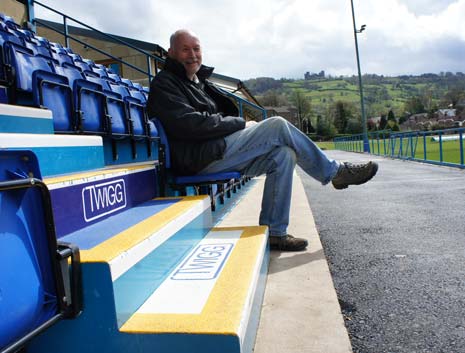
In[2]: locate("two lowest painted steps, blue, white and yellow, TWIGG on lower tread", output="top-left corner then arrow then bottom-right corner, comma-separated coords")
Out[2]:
30,190 -> 268,353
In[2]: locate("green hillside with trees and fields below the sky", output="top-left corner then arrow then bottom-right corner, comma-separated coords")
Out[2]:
245,73 -> 465,117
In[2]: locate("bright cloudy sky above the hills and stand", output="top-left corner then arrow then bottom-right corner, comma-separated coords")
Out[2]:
35,0 -> 465,80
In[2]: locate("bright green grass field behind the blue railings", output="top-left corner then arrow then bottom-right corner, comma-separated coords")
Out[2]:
332,136 -> 461,164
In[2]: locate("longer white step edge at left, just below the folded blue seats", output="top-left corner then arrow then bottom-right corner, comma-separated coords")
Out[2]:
0,134 -> 103,148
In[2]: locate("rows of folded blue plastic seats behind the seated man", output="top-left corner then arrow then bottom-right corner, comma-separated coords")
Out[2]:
0,13 -> 157,144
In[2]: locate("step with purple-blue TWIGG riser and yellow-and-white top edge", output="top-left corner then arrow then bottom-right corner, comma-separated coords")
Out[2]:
44,162 -> 158,238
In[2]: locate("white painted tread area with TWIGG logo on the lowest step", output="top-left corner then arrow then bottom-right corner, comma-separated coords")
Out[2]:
137,230 -> 242,314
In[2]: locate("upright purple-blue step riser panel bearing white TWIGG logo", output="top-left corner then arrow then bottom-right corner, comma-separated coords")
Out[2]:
51,169 -> 158,238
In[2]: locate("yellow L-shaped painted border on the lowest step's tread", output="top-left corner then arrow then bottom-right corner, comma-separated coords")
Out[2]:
120,226 -> 267,335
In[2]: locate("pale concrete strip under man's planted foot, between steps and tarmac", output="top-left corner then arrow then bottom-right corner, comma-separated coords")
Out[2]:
219,174 -> 352,353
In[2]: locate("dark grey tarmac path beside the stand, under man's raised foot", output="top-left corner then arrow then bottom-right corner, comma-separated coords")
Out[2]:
300,151 -> 465,353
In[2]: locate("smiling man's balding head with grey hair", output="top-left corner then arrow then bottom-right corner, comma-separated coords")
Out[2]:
168,29 -> 202,80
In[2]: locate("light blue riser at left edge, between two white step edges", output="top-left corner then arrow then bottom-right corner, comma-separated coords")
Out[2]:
0,115 -> 53,134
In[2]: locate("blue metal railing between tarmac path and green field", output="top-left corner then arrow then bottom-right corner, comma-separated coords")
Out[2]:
334,128 -> 465,168
